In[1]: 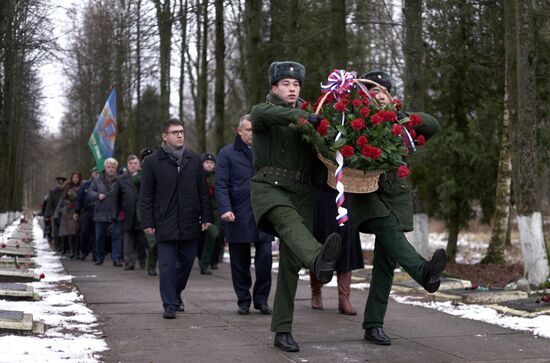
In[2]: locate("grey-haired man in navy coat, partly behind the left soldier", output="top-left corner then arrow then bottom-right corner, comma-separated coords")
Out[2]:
216,115 -> 273,315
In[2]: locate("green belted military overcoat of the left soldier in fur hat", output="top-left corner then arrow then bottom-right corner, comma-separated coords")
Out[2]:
250,92 -> 327,235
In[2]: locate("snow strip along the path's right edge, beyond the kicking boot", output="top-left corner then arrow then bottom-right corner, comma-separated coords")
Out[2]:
391,295 -> 550,338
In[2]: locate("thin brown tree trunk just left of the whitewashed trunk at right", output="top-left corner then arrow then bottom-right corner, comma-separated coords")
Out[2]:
481,1 -> 517,263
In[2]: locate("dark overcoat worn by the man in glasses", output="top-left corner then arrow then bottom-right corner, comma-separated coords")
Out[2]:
140,148 -> 212,241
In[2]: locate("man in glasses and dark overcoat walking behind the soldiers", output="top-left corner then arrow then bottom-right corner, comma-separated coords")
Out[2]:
140,119 -> 212,319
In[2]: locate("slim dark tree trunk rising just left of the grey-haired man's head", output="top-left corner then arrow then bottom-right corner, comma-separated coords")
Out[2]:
214,0 -> 225,152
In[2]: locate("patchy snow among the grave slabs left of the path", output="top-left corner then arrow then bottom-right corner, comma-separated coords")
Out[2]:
0,218 -> 109,363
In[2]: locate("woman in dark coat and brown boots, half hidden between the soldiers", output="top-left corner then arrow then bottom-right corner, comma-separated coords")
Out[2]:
309,191 -> 364,315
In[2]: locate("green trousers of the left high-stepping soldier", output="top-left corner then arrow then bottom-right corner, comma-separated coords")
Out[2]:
266,206 -> 322,333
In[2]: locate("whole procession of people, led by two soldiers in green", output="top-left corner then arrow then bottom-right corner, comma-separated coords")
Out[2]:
43,61 -> 446,352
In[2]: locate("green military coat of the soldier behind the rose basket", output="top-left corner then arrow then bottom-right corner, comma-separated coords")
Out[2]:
346,112 -> 439,233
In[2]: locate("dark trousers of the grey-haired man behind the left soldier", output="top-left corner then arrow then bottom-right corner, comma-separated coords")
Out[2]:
229,242 -> 272,308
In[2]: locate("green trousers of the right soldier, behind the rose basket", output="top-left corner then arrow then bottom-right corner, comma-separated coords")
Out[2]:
360,214 -> 426,329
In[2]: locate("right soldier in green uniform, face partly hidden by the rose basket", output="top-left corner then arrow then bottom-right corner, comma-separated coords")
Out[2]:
347,71 -> 446,345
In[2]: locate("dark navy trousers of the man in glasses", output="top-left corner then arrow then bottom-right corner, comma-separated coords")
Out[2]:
157,240 -> 198,309
